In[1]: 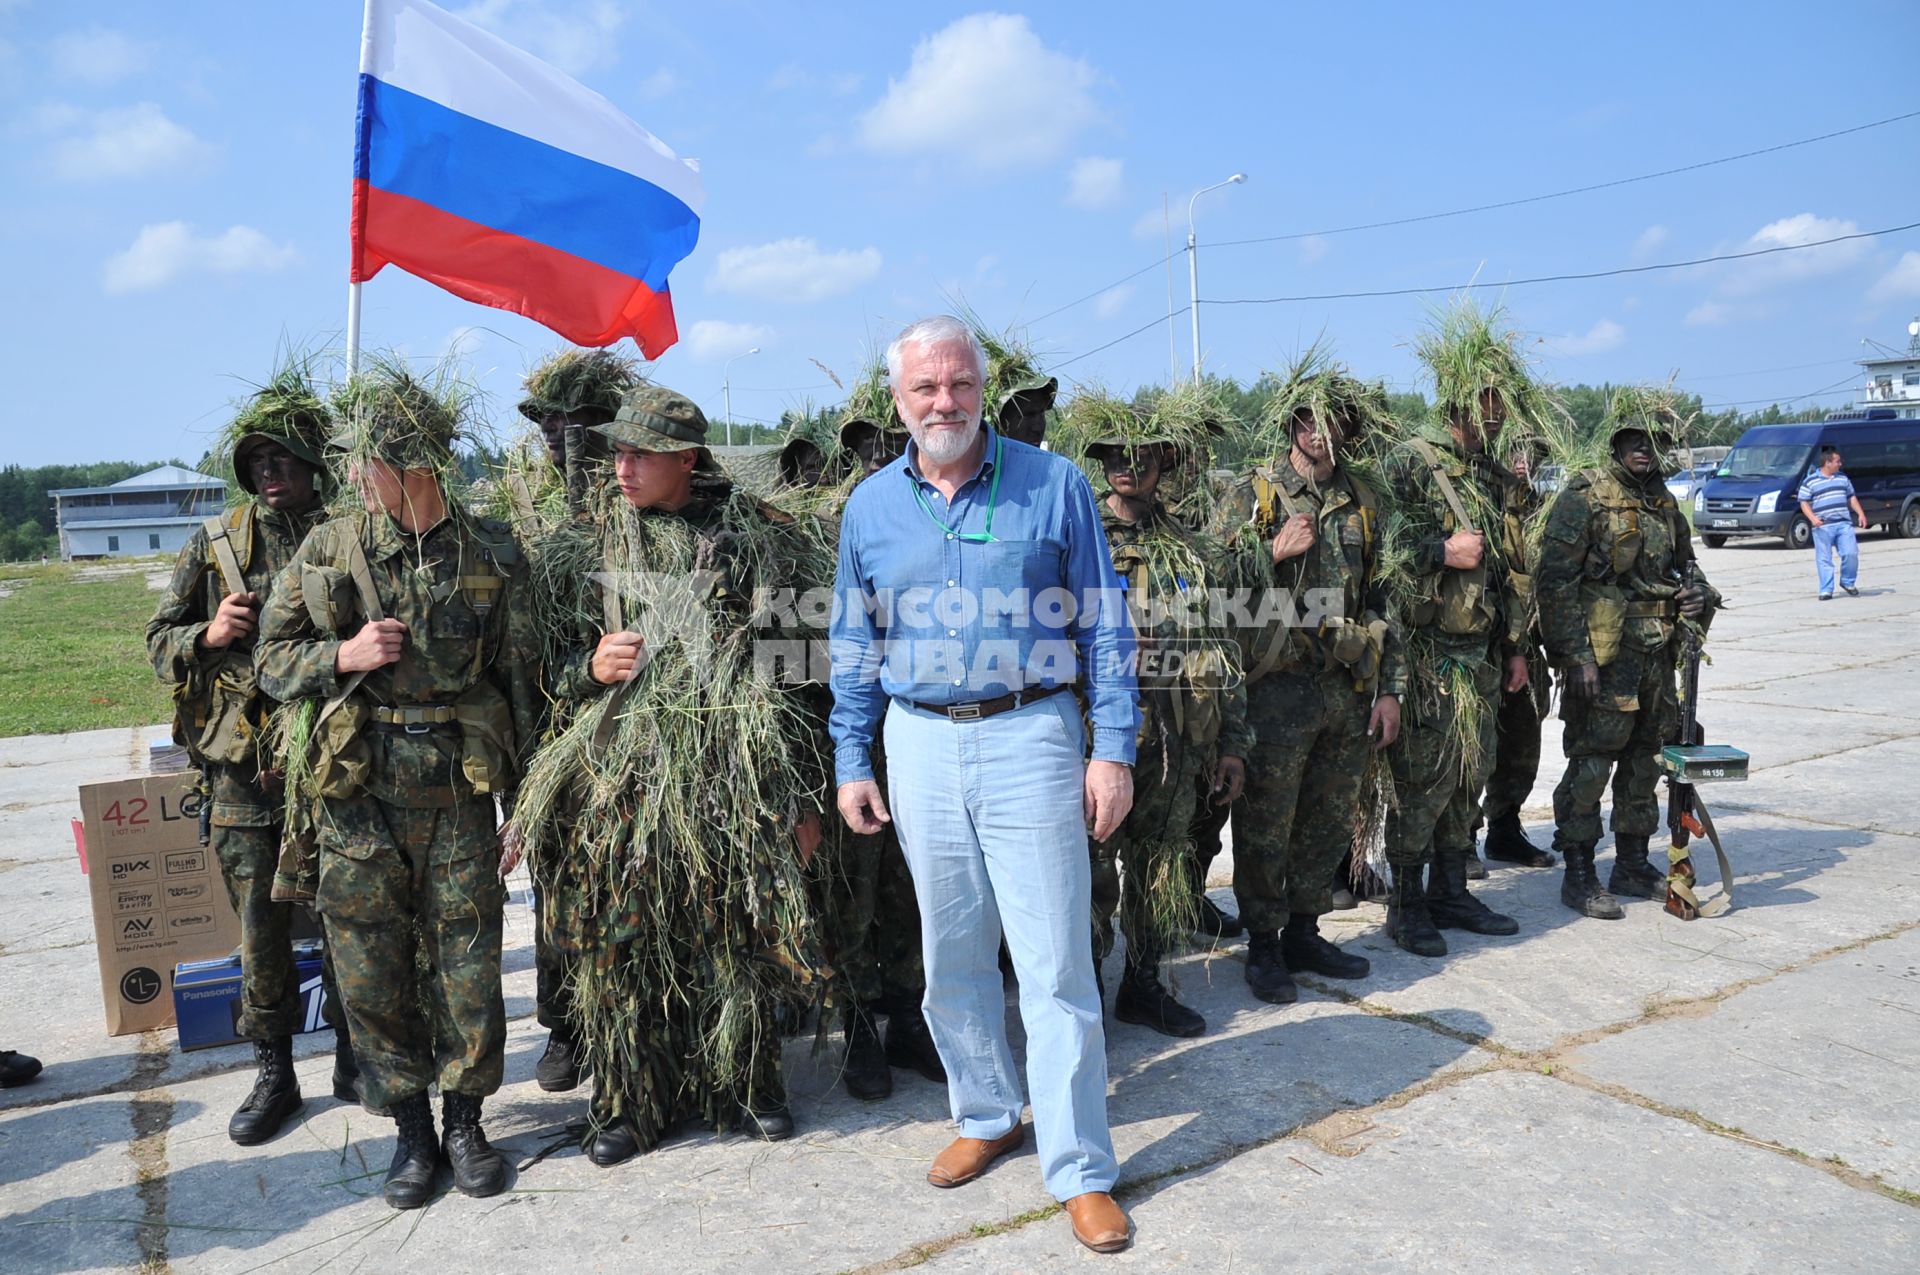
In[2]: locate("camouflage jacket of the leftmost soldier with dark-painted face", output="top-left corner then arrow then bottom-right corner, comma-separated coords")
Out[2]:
146,501 -> 324,828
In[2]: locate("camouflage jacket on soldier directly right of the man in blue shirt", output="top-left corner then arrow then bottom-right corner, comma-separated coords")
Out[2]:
1100,501 -> 1254,758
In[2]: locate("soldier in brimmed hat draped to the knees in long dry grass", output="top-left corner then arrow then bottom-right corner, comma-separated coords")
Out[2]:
515,386 -> 829,1166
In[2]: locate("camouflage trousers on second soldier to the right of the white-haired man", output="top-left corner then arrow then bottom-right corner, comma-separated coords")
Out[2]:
1233,668 -> 1373,933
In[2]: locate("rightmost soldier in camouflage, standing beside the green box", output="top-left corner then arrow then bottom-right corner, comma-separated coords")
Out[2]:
1538,386 -> 1720,920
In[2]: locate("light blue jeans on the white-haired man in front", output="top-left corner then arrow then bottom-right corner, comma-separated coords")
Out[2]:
883,693 -> 1119,1200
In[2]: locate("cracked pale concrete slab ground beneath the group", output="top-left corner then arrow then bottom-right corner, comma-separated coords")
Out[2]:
0,536 -> 1920,1273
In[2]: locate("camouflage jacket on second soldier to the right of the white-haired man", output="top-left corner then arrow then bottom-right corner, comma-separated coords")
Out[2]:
1213,457 -> 1407,695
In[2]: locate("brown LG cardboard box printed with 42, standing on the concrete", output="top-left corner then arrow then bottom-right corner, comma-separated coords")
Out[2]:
81,772 -> 240,1035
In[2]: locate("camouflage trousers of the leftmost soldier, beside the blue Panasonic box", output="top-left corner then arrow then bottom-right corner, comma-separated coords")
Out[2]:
213,824 -> 344,1041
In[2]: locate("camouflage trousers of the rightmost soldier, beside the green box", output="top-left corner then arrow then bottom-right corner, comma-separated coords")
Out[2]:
1553,649 -> 1678,849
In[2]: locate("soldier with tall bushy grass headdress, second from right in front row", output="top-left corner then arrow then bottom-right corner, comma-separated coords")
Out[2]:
1384,301 -> 1546,956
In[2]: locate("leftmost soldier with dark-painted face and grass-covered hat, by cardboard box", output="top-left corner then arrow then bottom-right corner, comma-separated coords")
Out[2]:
146,361 -> 359,1146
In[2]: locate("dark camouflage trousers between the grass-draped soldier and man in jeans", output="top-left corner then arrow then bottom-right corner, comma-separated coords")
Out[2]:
828,824 -> 927,1014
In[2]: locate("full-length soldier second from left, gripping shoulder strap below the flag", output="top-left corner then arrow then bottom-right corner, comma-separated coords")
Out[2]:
255,369 -> 541,1208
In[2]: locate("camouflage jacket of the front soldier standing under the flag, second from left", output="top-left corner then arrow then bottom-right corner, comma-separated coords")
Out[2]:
255,513 -> 541,806
